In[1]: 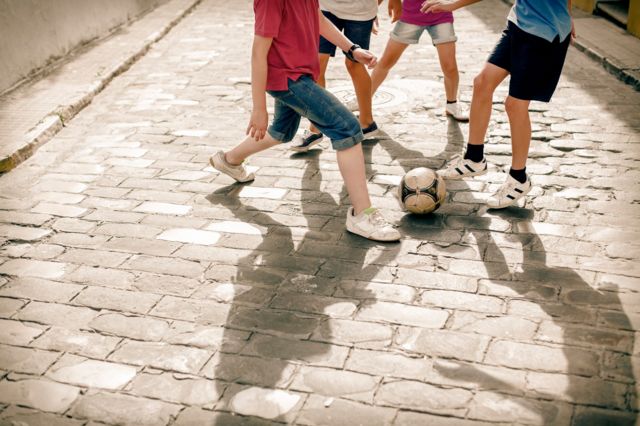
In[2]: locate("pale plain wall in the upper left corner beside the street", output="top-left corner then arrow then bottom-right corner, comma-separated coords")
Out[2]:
0,0 -> 168,93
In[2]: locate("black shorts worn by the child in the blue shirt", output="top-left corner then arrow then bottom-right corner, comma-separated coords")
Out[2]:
488,21 -> 571,102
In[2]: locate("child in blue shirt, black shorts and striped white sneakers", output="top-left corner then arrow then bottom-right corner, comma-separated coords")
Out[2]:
422,0 -> 575,209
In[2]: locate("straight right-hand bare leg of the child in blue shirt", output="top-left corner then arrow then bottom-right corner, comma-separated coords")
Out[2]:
504,96 -> 531,170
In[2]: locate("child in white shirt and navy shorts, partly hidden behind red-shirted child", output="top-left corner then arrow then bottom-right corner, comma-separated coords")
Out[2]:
291,0 -> 399,152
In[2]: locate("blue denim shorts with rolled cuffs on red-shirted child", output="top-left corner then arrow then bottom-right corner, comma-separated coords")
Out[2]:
267,75 -> 364,151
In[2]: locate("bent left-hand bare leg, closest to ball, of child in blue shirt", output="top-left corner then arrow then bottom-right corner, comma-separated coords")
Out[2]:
469,62 -> 509,145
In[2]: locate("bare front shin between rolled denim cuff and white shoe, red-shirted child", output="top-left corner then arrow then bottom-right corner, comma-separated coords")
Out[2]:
337,144 -> 371,215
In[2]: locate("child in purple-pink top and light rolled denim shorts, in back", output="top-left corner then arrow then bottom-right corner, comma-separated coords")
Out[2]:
371,0 -> 469,121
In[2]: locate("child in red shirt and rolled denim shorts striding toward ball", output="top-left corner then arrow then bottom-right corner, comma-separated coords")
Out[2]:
210,0 -> 400,241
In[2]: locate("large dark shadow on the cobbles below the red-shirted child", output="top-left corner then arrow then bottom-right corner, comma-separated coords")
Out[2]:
207,144 -> 400,425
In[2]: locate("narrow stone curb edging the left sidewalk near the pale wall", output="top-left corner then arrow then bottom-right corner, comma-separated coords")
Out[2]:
0,0 -> 202,173
